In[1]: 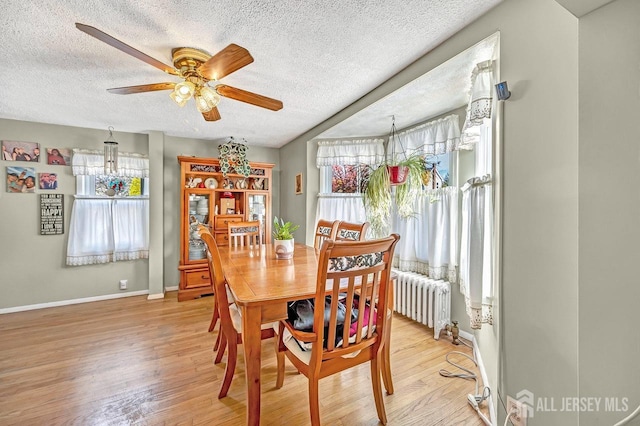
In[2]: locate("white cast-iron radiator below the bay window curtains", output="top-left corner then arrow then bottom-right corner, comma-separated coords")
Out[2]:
393,269 -> 451,340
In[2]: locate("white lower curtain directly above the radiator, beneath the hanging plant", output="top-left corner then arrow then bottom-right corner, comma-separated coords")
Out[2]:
392,187 -> 459,282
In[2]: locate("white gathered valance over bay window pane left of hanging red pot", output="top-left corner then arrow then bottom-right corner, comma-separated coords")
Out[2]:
316,139 -> 384,167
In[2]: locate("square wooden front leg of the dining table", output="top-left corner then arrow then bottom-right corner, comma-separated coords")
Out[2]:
242,306 -> 262,426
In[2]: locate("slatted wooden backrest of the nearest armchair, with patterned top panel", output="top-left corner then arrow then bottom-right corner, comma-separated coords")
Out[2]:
311,234 -> 400,362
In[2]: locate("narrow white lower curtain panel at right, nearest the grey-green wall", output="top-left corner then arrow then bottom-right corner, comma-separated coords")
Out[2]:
460,175 -> 493,329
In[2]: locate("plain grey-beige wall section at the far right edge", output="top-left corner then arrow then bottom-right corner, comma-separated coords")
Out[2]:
580,0 -> 640,426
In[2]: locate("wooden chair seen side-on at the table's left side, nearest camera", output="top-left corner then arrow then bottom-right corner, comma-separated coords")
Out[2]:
198,225 -> 284,399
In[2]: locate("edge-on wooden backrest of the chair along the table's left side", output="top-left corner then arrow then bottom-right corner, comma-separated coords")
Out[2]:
198,225 -> 235,337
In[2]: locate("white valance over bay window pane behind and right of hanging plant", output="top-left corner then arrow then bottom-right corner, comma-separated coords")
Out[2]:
388,114 -> 460,157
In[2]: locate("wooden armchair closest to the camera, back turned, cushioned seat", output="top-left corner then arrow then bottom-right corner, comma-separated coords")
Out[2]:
276,234 -> 400,426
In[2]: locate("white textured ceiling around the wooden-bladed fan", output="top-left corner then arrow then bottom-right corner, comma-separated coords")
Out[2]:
0,0 -> 500,147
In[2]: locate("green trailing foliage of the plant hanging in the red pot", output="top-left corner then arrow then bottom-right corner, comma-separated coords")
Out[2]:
363,155 -> 425,236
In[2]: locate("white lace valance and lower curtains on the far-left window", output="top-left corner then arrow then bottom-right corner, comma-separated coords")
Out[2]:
67,149 -> 149,266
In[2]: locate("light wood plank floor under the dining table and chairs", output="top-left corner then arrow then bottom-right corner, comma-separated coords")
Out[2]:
0,292 -> 487,426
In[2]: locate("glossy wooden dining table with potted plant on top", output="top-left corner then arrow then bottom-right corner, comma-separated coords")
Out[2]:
219,243 -> 320,425
